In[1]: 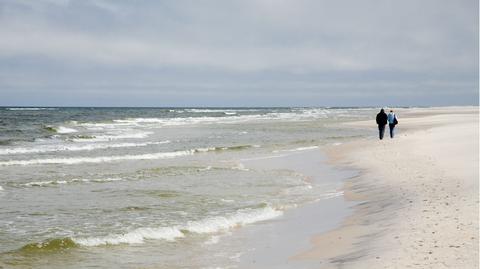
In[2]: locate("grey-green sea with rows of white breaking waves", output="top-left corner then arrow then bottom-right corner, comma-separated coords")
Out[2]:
0,107 -> 377,269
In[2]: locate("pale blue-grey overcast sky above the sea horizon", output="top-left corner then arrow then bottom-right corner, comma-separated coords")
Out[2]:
0,0 -> 479,106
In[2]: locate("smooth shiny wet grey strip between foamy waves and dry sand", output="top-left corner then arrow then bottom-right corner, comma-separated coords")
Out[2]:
236,148 -> 357,269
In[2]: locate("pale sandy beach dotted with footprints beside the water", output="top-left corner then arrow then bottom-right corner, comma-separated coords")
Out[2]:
298,107 -> 479,268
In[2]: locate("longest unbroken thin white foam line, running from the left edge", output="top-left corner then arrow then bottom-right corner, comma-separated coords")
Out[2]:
0,150 -> 195,166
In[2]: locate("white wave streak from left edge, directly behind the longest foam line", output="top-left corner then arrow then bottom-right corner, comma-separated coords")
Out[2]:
0,140 -> 170,155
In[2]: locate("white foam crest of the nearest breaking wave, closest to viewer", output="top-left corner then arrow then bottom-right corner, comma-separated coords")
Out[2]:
73,207 -> 283,247
